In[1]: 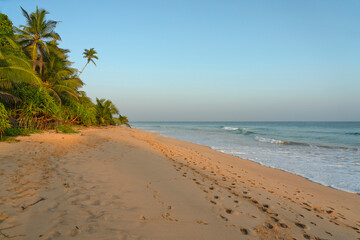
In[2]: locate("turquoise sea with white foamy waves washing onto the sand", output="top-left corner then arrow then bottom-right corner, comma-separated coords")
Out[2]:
132,122 -> 360,193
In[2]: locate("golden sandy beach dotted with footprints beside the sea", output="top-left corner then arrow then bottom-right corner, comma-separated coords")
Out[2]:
0,127 -> 360,240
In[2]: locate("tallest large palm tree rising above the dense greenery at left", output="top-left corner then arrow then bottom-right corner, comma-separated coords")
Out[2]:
16,7 -> 61,74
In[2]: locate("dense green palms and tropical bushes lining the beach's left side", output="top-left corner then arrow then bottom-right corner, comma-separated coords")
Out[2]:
0,7 -> 129,139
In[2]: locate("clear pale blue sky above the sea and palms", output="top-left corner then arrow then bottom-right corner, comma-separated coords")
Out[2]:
0,0 -> 360,121
